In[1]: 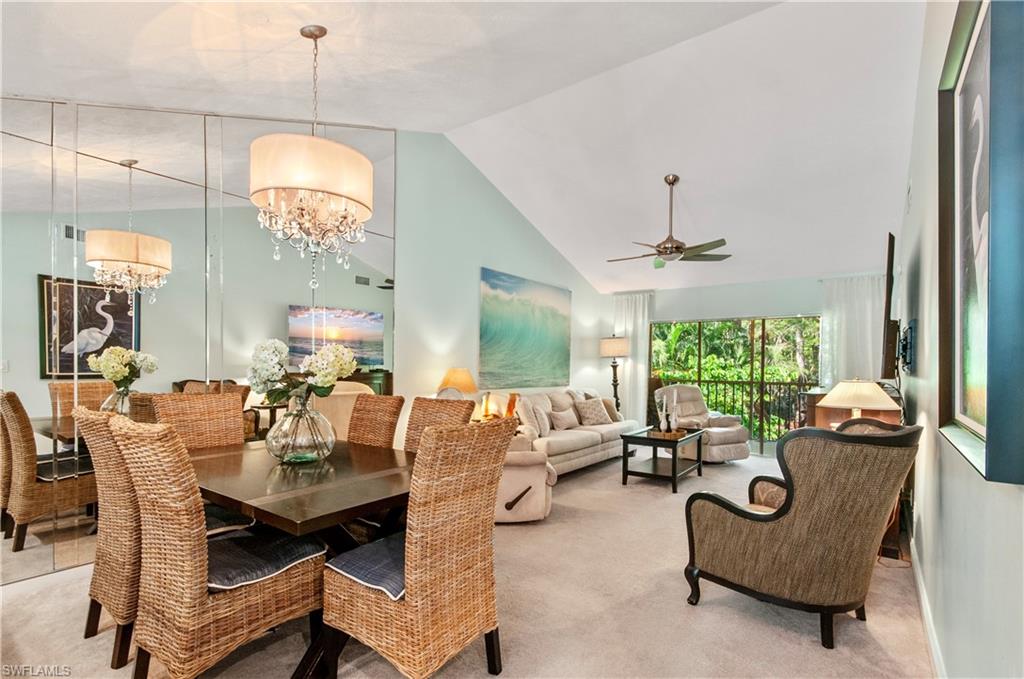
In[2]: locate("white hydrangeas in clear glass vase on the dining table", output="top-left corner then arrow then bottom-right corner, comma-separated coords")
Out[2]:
248,339 -> 355,464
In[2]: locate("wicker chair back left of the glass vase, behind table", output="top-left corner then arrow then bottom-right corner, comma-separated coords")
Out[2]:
153,393 -> 246,450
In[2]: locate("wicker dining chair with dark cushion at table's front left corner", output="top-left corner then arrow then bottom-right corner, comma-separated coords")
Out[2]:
111,416 -> 325,679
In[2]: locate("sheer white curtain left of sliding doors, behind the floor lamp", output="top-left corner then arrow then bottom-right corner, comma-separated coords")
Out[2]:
614,292 -> 652,424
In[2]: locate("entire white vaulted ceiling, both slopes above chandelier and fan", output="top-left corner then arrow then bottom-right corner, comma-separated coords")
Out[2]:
2,2 -> 924,292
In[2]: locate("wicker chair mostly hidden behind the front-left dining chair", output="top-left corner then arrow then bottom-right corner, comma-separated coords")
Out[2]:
74,406 -> 142,625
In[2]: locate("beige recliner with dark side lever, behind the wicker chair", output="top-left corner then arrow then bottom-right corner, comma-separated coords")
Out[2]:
495,436 -> 558,523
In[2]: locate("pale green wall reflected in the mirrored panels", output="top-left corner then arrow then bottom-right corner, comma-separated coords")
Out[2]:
0,208 -> 394,416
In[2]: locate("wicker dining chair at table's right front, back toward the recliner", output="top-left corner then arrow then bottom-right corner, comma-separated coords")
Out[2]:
293,418 -> 517,679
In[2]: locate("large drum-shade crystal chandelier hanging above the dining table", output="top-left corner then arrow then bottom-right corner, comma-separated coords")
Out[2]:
249,26 -> 374,289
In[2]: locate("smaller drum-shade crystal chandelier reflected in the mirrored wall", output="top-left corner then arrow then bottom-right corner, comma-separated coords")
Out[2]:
85,160 -> 171,315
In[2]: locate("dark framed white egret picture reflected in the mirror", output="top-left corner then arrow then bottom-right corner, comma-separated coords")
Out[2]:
38,273 -> 139,380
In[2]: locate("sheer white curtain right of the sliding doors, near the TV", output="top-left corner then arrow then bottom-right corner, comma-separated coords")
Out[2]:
820,275 -> 886,387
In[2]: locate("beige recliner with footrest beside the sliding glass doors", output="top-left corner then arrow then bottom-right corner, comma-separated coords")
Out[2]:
654,384 -> 751,462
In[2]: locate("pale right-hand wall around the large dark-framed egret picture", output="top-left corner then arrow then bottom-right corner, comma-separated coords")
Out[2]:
895,3 -> 1024,677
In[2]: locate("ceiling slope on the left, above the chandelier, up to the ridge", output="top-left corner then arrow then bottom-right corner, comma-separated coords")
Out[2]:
2,2 -> 766,131
